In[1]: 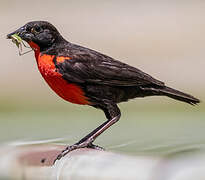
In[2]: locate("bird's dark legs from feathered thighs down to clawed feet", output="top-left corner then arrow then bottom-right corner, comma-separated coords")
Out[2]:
54,103 -> 121,163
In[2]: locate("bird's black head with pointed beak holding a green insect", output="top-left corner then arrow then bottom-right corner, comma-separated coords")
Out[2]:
7,21 -> 62,50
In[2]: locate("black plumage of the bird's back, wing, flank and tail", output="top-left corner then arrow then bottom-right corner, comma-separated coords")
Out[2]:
48,42 -> 199,105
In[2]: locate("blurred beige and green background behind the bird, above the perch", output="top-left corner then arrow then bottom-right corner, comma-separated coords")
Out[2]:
0,0 -> 205,155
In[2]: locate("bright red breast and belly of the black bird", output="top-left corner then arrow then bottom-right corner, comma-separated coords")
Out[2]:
38,55 -> 90,104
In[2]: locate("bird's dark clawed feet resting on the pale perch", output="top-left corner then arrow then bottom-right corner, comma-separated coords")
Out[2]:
53,142 -> 104,164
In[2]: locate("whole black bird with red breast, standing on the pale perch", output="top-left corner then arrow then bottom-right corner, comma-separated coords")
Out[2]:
7,21 -> 200,162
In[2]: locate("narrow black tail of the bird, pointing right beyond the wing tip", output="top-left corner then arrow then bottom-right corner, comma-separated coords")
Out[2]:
159,86 -> 200,105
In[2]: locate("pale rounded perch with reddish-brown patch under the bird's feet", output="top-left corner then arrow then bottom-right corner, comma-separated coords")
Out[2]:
0,144 -> 205,180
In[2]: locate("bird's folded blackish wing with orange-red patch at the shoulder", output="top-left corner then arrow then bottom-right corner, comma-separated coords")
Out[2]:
56,45 -> 164,86
